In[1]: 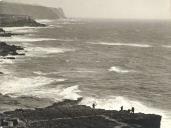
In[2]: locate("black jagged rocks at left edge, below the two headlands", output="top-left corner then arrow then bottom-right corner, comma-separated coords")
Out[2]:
0,42 -> 23,56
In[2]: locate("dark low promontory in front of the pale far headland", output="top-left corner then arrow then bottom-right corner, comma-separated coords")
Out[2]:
0,14 -> 45,27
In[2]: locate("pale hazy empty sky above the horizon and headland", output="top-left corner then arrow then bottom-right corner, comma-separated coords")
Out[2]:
3,0 -> 171,19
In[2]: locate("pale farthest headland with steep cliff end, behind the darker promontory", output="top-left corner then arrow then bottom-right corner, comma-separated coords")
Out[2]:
0,1 -> 65,19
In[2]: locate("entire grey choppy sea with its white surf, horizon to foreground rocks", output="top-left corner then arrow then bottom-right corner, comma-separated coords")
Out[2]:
0,19 -> 171,128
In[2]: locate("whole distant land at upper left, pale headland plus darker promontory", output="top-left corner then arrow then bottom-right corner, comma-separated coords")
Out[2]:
0,1 -> 66,27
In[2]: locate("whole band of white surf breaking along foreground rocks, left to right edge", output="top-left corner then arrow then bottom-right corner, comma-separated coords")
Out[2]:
0,76 -> 168,128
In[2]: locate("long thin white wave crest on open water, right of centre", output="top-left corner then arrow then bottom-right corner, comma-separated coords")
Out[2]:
88,42 -> 152,48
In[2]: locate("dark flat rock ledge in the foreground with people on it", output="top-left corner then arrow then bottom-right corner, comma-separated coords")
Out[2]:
1,98 -> 161,128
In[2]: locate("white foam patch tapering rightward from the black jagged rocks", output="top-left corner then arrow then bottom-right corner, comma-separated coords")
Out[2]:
25,47 -> 74,57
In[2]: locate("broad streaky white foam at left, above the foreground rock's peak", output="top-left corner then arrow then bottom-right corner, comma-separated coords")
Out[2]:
0,76 -> 80,101
